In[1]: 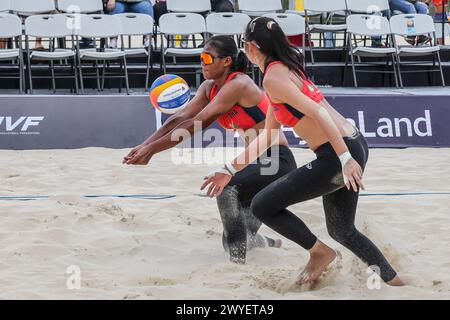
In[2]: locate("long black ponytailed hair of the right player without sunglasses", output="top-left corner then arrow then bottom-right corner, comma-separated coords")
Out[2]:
245,17 -> 307,78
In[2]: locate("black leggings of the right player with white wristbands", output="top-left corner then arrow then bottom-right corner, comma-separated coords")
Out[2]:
251,132 -> 396,282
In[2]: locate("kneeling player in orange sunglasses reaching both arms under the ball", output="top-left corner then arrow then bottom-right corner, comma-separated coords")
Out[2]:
123,36 -> 296,263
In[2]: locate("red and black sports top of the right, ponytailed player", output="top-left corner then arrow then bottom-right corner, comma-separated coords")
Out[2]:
265,61 -> 325,127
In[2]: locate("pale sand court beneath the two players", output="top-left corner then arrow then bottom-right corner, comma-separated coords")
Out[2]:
0,148 -> 450,299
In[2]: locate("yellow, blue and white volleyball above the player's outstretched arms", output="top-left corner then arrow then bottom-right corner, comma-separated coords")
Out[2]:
150,74 -> 191,114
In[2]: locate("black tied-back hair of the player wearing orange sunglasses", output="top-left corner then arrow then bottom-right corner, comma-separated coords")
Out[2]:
205,36 -> 248,73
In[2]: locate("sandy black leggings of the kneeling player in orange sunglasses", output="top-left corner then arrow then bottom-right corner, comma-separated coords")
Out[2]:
217,145 -> 297,264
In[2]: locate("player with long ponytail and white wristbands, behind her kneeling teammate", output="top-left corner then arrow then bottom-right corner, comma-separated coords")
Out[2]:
202,17 -> 402,285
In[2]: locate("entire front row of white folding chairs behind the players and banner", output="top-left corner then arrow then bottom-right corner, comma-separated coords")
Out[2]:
0,13 -> 444,89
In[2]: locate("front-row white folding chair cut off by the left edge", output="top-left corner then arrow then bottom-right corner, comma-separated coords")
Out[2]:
0,13 -> 25,93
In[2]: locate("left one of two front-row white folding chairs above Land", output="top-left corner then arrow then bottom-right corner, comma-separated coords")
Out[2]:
343,14 -> 398,88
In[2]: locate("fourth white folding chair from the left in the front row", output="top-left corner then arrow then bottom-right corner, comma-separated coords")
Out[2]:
116,13 -> 154,90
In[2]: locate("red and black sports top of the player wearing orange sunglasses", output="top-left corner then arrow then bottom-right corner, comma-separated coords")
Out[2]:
209,72 -> 270,131
